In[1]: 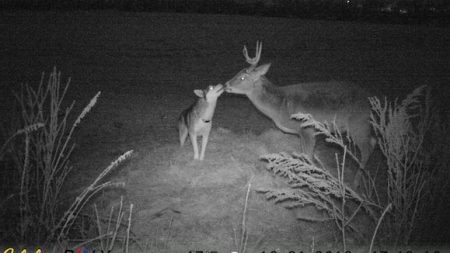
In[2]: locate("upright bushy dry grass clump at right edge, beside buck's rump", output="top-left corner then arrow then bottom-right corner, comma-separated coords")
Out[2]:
369,86 -> 450,246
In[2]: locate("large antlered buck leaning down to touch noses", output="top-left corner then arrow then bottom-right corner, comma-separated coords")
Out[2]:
225,42 -> 375,187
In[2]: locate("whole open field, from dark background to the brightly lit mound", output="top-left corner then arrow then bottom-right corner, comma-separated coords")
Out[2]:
0,11 -> 450,252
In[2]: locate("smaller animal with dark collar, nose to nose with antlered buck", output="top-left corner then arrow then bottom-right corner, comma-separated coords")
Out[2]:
178,84 -> 224,161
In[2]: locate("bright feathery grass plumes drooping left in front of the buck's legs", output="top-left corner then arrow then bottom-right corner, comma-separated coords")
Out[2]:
259,113 -> 382,247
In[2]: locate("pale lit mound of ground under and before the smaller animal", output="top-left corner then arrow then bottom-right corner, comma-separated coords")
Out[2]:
127,128 -> 356,252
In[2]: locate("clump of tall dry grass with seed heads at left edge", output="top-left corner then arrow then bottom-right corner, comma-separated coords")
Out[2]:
0,68 -> 132,247
